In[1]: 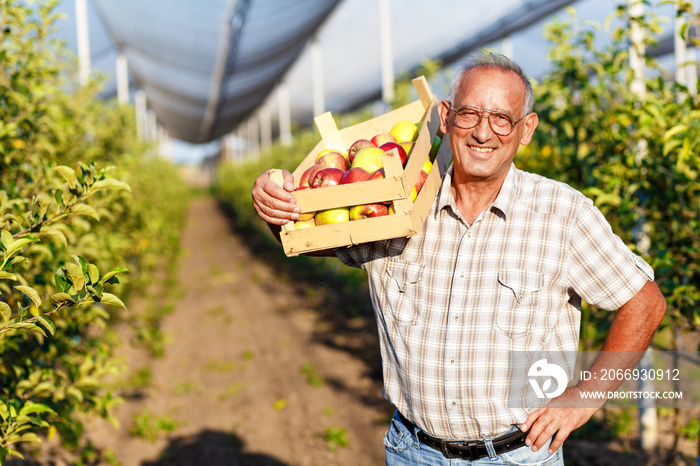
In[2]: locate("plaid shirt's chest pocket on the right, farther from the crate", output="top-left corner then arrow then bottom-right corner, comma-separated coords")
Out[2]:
494,269 -> 544,338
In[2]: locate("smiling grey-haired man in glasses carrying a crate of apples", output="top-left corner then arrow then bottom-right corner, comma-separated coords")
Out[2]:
252,52 -> 666,465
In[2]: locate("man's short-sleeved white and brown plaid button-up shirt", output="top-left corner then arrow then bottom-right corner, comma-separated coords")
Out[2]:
336,166 -> 653,440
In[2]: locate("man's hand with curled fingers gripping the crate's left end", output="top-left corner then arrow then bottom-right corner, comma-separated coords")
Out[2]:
251,170 -> 301,225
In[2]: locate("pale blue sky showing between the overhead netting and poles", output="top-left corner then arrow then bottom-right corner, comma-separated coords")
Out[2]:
50,0 -> 697,162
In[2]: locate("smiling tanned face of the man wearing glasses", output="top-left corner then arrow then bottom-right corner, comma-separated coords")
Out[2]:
439,67 -> 538,183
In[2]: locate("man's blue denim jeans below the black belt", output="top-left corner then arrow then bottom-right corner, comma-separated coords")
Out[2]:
384,414 -> 564,466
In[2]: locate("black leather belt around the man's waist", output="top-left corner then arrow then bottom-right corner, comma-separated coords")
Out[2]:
399,413 -> 527,461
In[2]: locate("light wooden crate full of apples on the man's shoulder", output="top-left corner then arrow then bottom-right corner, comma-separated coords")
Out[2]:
270,76 -> 451,257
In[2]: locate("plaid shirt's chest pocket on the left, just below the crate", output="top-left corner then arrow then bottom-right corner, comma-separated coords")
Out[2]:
384,259 -> 425,326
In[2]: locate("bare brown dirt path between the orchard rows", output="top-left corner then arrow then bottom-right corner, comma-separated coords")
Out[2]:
82,198 -> 391,466
